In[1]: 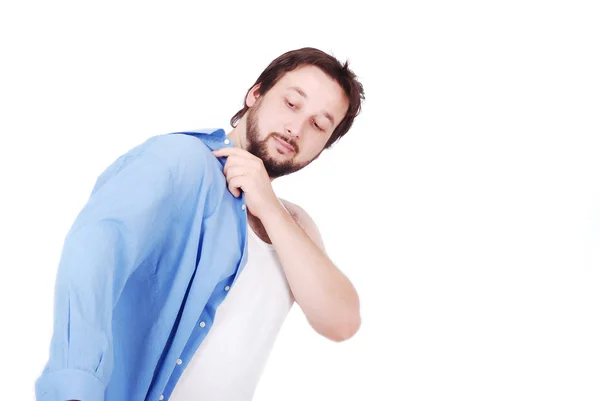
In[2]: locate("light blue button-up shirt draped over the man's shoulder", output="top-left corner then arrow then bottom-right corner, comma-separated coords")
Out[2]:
35,129 -> 247,401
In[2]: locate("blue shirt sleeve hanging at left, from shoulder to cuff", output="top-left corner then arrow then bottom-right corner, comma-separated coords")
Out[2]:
35,137 -> 182,401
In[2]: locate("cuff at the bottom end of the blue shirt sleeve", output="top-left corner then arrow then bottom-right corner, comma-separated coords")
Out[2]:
35,369 -> 106,401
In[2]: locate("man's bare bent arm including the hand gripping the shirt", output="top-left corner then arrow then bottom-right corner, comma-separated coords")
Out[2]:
212,148 -> 360,341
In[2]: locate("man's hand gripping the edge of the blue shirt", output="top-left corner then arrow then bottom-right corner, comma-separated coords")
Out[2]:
213,147 -> 281,220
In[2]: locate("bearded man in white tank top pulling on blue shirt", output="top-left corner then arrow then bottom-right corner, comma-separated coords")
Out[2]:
36,48 -> 364,401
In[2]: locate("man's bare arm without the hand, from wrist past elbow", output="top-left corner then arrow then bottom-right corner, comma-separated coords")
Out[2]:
261,205 -> 361,341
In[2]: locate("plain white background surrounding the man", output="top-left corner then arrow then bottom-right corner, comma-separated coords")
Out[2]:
0,1 -> 600,401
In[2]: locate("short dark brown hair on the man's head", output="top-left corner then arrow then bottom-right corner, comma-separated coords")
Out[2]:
231,47 -> 365,148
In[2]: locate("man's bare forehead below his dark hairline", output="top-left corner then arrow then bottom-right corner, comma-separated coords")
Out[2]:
273,66 -> 348,125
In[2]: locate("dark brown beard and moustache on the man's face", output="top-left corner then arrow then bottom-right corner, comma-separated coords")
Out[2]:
246,99 -> 314,179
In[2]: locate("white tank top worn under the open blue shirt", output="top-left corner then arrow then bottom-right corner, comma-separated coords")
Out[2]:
169,205 -> 294,401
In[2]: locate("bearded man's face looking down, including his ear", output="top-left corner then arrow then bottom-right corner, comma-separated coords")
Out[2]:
246,66 -> 348,178
